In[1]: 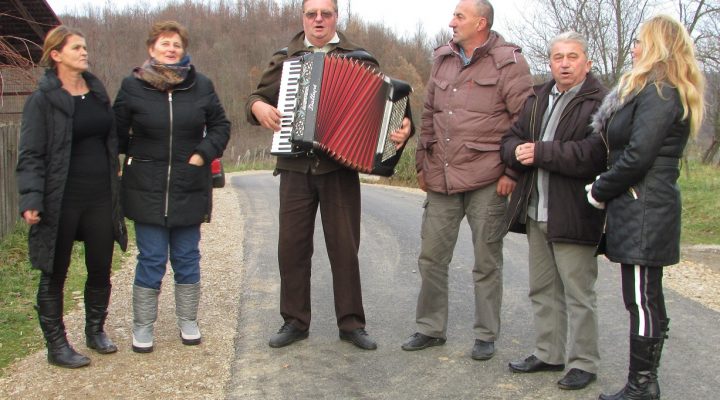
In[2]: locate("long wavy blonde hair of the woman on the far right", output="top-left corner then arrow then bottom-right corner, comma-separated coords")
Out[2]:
618,15 -> 705,135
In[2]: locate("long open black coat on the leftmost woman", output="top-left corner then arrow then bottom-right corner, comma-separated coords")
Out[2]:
16,69 -> 127,273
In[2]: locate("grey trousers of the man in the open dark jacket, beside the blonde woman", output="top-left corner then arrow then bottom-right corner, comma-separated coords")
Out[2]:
526,218 -> 600,374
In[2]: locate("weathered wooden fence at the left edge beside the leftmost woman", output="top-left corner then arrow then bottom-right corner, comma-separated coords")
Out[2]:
0,124 -> 20,240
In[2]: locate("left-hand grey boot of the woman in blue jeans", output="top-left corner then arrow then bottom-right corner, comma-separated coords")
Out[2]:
132,285 -> 160,353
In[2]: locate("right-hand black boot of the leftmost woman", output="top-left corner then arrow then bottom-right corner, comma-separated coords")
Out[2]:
85,285 -> 117,354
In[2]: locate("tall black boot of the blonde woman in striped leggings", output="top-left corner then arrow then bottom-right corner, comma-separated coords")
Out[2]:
599,334 -> 661,400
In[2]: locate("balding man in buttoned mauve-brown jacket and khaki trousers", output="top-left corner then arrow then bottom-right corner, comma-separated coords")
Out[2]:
402,0 -> 532,360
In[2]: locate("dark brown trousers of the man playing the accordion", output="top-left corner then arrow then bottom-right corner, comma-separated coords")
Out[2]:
278,168 -> 365,331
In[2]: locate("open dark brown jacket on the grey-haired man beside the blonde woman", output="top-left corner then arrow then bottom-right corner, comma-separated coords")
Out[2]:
500,74 -> 607,245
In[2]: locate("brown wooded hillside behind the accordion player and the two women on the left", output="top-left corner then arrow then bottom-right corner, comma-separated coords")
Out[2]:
61,0 -> 432,166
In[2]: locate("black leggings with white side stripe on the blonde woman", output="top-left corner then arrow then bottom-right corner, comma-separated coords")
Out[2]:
621,264 -> 667,337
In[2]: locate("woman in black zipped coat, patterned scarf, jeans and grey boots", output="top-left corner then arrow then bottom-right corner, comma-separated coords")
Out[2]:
114,21 -> 230,353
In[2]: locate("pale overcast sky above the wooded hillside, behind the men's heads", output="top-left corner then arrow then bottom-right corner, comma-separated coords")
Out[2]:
46,0 -> 530,36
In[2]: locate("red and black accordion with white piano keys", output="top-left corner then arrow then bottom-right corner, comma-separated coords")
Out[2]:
270,52 -> 412,176
